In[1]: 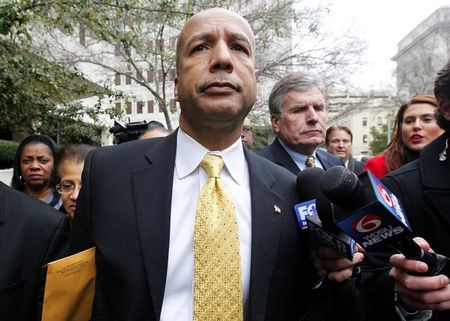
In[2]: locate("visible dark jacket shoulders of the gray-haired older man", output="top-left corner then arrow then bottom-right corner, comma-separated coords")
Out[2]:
259,138 -> 344,175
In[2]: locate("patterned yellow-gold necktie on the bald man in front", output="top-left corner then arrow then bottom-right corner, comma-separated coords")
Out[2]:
194,154 -> 243,321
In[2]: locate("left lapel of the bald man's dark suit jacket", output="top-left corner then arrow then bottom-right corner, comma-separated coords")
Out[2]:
132,133 -> 176,320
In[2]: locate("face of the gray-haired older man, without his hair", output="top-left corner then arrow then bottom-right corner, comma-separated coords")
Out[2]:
271,88 -> 328,154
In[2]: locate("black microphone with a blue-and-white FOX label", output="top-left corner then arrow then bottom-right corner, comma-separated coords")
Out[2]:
294,167 -> 357,260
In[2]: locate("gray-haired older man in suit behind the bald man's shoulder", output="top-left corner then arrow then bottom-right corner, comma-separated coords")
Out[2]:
260,72 -> 343,175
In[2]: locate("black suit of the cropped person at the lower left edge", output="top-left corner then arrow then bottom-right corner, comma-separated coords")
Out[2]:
0,182 -> 68,321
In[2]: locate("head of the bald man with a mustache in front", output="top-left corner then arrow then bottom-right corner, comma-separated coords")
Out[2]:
175,9 -> 256,131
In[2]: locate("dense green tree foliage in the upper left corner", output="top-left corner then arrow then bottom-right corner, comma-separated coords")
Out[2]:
0,0 -> 121,141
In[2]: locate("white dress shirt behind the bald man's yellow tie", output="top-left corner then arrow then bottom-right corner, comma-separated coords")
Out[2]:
161,128 -> 251,321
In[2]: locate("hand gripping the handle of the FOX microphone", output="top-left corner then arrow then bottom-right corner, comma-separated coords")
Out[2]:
311,246 -> 364,282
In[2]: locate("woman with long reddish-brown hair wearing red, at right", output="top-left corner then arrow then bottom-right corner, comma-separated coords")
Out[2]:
364,95 -> 443,178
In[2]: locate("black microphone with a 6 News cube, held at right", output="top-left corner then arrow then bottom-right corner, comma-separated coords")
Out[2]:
318,166 -> 447,275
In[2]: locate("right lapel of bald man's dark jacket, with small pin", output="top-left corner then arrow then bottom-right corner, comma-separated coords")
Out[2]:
245,151 -> 288,320
